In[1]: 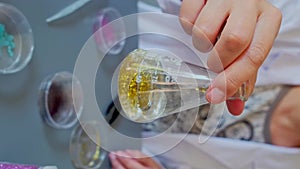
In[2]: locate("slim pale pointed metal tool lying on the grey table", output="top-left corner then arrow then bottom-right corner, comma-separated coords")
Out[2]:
46,0 -> 91,23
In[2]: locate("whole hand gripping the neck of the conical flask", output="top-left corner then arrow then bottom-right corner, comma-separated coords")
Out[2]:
180,0 -> 282,115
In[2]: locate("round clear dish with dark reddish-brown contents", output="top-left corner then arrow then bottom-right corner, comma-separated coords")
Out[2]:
38,72 -> 83,129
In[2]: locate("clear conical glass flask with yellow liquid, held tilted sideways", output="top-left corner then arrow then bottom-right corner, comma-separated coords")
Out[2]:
118,49 -> 247,123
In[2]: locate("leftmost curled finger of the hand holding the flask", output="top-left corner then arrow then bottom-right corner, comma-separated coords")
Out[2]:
179,0 -> 205,35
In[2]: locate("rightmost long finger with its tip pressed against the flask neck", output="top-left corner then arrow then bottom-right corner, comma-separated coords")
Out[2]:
207,2 -> 281,103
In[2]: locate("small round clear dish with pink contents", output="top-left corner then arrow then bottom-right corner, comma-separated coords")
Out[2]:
93,7 -> 126,55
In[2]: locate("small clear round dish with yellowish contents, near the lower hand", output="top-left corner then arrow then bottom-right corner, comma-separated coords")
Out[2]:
69,122 -> 107,169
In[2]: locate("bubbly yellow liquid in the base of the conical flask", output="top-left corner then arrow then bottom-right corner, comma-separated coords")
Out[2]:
118,50 -> 170,119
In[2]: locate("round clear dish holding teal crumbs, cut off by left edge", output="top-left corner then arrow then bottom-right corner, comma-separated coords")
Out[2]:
0,3 -> 34,74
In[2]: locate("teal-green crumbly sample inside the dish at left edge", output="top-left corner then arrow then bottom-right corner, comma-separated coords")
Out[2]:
0,24 -> 16,57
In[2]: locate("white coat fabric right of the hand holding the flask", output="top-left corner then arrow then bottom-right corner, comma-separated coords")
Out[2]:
257,0 -> 300,85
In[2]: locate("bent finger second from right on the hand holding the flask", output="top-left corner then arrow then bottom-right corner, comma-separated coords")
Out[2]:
207,1 -> 259,72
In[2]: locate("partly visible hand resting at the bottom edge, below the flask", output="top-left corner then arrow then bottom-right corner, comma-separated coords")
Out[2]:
109,150 -> 161,169
